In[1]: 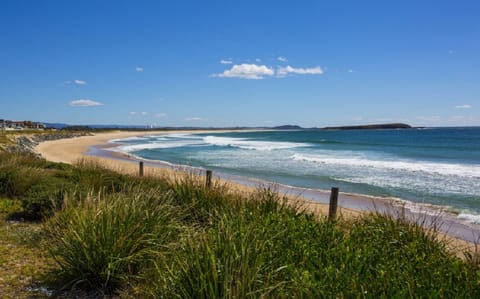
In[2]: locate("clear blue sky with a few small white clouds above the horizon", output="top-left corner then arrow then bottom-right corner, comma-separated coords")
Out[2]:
0,0 -> 480,127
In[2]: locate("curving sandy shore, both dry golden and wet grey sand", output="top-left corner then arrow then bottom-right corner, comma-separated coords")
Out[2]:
35,130 -> 480,255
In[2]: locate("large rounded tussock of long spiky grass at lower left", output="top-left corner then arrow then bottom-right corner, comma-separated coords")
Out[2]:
45,190 -> 186,293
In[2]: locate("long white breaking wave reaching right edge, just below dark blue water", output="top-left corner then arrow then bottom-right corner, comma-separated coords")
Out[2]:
291,153 -> 480,178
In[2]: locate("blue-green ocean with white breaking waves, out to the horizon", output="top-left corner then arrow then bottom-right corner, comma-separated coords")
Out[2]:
112,127 -> 480,224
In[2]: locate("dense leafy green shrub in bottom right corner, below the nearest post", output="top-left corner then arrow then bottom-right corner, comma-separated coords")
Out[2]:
338,214 -> 480,298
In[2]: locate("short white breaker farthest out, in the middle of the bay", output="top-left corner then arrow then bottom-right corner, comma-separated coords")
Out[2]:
203,136 -> 308,151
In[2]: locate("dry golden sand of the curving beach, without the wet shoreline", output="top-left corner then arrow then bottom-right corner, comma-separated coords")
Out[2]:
35,131 -> 476,258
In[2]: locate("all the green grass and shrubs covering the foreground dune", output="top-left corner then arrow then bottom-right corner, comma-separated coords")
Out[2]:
0,154 -> 480,298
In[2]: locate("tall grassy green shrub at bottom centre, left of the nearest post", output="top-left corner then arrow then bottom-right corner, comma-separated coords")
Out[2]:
145,189 -> 342,298
